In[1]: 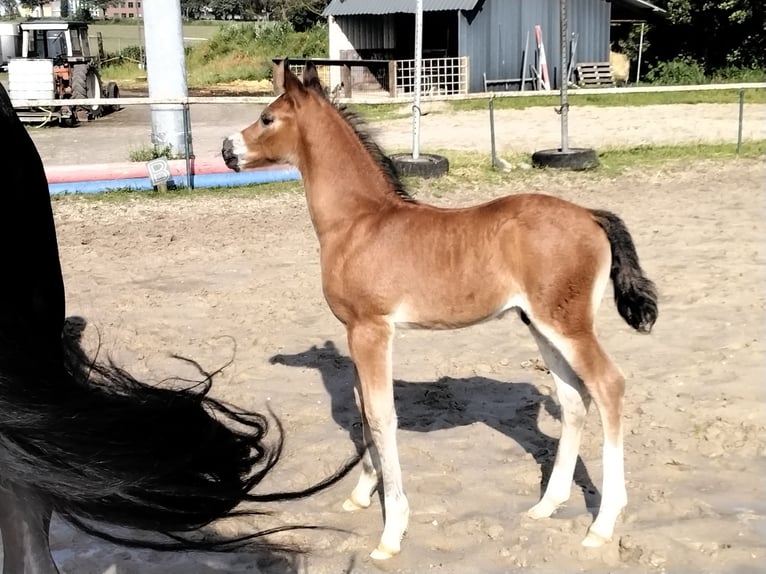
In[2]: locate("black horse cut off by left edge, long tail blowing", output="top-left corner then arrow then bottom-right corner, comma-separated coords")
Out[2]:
0,86 -> 350,574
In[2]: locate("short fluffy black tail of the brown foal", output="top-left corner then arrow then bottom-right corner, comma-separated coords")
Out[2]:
591,209 -> 658,333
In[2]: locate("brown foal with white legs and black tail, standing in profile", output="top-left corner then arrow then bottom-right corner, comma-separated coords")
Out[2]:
222,65 -> 657,559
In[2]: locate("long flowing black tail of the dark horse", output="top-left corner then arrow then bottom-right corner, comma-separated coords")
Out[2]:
0,329 -> 358,550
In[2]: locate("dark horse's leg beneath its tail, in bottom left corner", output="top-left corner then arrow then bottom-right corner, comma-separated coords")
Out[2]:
0,484 -> 58,574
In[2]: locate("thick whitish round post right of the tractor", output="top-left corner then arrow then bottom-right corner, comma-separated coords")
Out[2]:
143,0 -> 188,154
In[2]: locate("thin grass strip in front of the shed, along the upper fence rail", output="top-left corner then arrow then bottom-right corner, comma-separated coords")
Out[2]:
449,89 -> 766,111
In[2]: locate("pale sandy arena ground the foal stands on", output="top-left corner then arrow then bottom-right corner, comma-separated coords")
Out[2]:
27,155 -> 766,574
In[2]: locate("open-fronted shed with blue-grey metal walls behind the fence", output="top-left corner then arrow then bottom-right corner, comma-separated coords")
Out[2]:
324,0 -> 661,93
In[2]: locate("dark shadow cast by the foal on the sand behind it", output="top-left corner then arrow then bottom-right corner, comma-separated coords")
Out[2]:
270,341 -> 601,516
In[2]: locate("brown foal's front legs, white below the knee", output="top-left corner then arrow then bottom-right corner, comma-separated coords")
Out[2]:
348,319 -> 410,560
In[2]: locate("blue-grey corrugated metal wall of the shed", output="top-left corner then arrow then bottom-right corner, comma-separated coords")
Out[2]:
458,0 -> 611,92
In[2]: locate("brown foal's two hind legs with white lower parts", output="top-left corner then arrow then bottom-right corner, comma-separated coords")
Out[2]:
530,324 -> 628,547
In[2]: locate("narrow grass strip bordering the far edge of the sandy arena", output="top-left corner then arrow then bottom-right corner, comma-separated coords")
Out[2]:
53,140 -> 766,202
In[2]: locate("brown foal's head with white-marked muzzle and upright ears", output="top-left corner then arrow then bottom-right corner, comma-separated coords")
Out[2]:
221,61 -> 329,171
